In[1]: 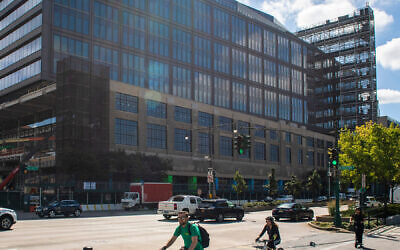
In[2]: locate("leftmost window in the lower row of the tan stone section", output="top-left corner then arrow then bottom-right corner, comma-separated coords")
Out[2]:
114,118 -> 138,146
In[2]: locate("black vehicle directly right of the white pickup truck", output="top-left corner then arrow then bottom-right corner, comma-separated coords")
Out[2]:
195,199 -> 244,222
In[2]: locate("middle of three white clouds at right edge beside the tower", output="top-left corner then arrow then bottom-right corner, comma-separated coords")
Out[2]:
376,38 -> 400,70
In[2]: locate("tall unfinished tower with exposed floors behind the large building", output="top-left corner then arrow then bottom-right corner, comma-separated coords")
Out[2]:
296,6 -> 378,131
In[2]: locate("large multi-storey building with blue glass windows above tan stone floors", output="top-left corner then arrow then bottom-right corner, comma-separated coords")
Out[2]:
0,0 -> 334,194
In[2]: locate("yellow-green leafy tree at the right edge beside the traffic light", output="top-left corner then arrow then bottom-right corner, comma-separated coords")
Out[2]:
339,122 -> 400,217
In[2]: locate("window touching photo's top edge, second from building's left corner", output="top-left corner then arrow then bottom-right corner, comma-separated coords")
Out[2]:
93,1 -> 119,43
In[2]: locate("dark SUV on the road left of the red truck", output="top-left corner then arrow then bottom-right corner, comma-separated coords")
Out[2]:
36,200 -> 82,218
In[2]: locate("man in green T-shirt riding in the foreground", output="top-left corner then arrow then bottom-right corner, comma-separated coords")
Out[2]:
161,211 -> 203,250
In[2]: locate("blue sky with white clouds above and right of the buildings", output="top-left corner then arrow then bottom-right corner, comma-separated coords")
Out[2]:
238,0 -> 400,121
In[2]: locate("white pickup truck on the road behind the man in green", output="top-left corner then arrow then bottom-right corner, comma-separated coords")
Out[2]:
157,195 -> 202,220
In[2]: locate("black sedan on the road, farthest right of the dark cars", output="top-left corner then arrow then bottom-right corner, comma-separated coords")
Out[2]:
272,203 -> 314,221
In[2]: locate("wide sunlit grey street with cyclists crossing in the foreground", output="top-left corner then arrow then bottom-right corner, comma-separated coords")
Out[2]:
0,208 -> 400,250
